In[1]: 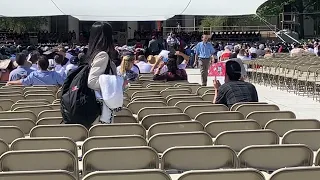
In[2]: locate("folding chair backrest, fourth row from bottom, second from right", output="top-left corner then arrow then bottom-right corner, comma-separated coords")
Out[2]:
205,120 -> 261,137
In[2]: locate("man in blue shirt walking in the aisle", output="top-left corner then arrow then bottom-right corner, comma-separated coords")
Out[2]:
195,35 -> 215,86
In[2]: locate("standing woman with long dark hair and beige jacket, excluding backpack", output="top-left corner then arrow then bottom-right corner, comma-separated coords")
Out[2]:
86,22 -> 117,91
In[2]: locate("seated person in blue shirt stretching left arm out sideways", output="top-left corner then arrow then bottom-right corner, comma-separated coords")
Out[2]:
7,56 -> 64,86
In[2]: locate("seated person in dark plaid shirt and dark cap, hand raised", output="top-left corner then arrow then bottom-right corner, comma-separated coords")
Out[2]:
213,61 -> 258,108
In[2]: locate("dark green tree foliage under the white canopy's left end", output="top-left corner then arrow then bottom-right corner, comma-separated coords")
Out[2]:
0,17 -> 48,32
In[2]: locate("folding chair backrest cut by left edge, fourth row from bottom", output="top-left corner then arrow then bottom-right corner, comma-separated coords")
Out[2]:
0,126 -> 24,144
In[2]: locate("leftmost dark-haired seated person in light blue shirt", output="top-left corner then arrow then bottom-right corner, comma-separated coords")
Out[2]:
9,53 -> 33,81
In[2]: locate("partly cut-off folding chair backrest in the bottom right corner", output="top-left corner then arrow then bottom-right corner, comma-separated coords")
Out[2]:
270,167 -> 320,180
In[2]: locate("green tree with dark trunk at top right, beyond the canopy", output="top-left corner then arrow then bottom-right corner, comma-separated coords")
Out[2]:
257,0 -> 317,38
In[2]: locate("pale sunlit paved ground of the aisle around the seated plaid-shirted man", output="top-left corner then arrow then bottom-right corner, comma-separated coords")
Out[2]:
187,69 -> 320,120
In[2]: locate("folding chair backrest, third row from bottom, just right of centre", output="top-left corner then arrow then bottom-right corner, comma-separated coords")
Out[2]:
148,131 -> 213,153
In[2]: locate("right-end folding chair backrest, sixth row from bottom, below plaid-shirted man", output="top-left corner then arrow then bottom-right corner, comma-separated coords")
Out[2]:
235,104 -> 280,117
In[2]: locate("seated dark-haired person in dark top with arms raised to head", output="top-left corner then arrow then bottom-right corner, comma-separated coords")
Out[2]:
153,53 -> 188,81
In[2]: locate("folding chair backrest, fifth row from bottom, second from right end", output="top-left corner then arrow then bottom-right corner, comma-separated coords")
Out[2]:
195,111 -> 244,125
